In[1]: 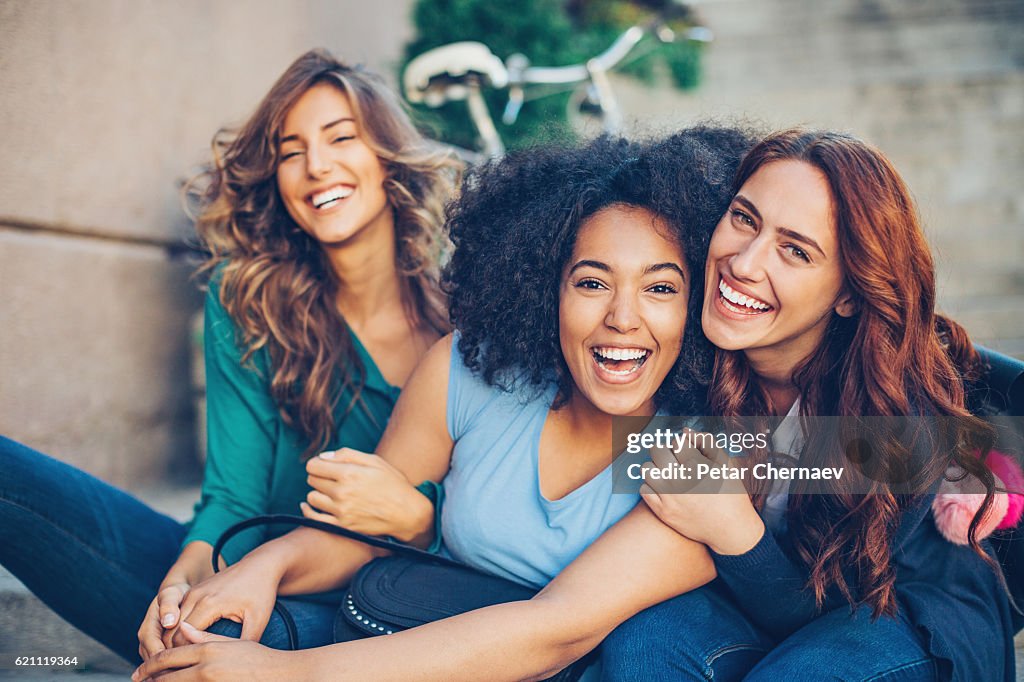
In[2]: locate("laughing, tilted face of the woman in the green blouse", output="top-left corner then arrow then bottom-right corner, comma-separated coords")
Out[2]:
278,83 -> 394,247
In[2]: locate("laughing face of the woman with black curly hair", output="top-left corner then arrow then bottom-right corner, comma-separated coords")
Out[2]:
558,205 -> 689,416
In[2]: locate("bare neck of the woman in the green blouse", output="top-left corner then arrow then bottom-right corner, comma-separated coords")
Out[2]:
325,210 -> 402,330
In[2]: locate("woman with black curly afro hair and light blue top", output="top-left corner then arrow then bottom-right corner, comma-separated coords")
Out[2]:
136,128 -> 749,680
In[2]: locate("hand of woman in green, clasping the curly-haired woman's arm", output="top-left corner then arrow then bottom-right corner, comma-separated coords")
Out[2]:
301,447 -> 434,542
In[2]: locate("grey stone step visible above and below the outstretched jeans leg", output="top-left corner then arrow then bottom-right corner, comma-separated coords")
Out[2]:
0,487 -> 199,681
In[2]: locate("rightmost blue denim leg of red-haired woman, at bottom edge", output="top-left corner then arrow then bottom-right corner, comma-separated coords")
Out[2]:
746,607 -> 938,682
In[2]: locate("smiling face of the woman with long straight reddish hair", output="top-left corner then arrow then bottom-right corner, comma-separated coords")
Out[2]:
701,161 -> 853,376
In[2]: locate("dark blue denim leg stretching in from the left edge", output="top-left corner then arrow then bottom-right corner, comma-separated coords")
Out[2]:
0,436 -> 185,663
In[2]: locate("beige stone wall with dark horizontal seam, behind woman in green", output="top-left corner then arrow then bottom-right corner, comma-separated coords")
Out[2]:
0,0 -> 410,488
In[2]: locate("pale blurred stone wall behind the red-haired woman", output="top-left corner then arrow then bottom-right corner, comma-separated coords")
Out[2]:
616,0 -> 1024,357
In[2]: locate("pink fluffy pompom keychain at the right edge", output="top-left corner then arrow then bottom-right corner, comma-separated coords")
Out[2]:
932,451 -> 1024,545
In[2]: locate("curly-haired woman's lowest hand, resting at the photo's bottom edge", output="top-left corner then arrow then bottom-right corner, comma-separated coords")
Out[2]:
131,623 -> 292,682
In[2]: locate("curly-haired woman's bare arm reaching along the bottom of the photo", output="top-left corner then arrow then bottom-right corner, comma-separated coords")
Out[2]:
140,505 -> 715,680
